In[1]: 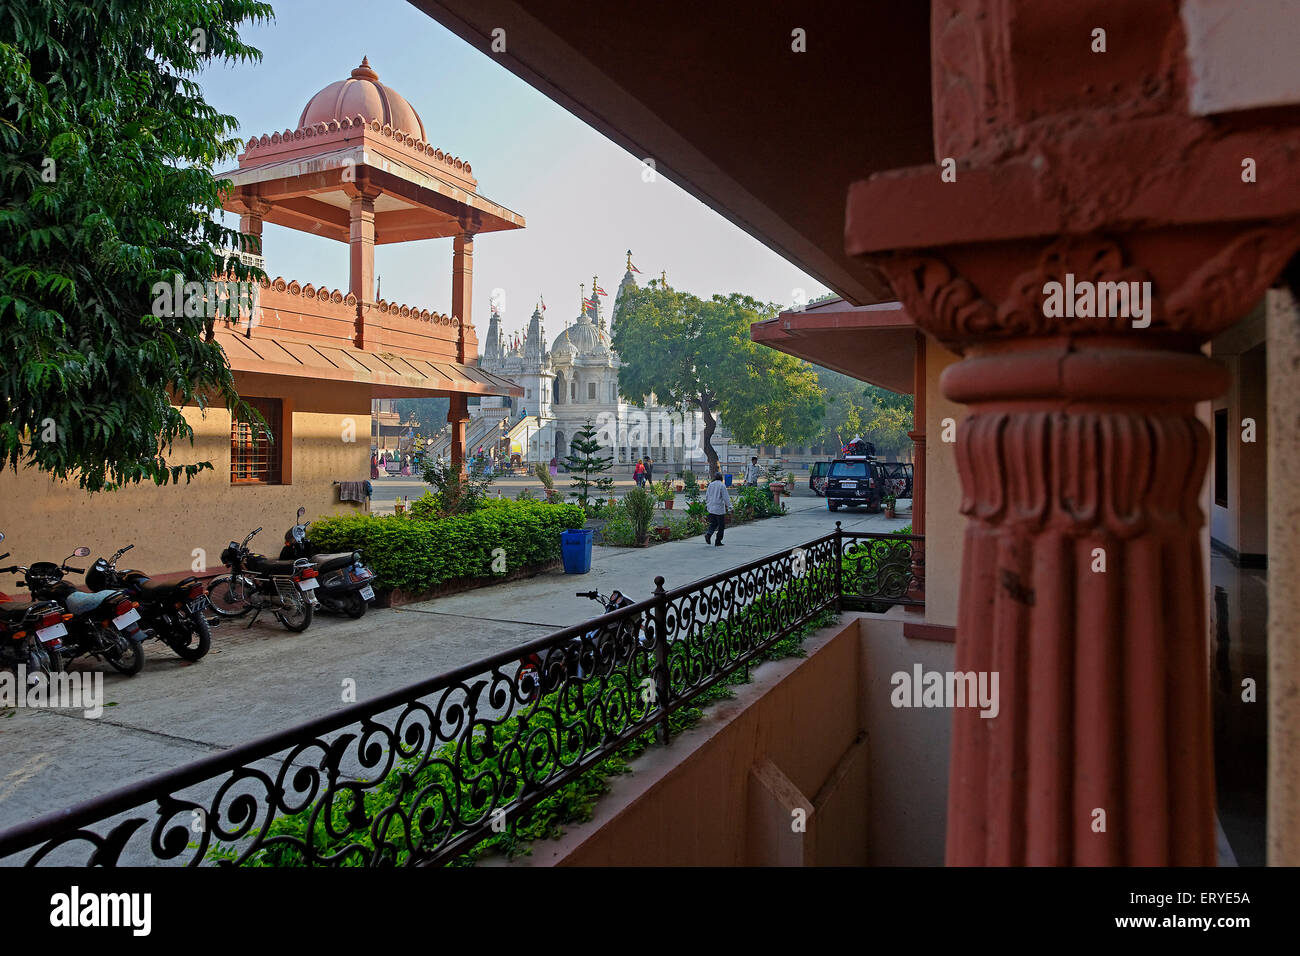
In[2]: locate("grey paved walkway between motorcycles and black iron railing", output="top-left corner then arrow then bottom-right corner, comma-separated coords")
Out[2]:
0,492 -> 910,829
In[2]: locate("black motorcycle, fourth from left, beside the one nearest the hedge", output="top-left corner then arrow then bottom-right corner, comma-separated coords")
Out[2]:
208,528 -> 320,633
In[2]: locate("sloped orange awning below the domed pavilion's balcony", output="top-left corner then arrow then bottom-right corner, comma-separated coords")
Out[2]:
216,330 -> 524,398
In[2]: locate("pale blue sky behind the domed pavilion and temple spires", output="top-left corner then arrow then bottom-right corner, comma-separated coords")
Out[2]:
199,0 -> 827,341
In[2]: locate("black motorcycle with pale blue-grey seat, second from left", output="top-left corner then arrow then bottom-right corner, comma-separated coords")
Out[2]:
15,548 -> 152,675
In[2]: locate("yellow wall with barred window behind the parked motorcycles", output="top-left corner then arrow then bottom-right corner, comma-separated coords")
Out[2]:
0,375 -> 371,582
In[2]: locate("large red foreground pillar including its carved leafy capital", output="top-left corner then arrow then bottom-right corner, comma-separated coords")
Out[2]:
846,0 -> 1300,866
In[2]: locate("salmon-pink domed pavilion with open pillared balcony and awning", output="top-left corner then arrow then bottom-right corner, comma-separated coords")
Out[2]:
217,59 -> 524,462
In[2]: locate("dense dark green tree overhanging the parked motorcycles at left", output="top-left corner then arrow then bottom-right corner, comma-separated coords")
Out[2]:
0,0 -> 272,490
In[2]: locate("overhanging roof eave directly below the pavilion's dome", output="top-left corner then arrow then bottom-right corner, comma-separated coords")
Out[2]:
216,144 -> 527,233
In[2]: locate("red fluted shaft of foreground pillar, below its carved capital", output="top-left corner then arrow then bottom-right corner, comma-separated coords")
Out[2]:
944,339 -> 1227,866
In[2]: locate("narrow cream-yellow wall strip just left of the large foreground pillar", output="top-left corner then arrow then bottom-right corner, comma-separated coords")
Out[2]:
926,338 -> 966,627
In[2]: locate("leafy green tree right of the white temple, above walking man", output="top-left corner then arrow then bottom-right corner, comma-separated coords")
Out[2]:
614,281 -> 824,472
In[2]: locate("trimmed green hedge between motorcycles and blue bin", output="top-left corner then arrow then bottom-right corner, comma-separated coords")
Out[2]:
311,501 -> 586,593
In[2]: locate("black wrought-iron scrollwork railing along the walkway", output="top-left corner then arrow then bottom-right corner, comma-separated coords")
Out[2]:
0,524 -> 922,866
